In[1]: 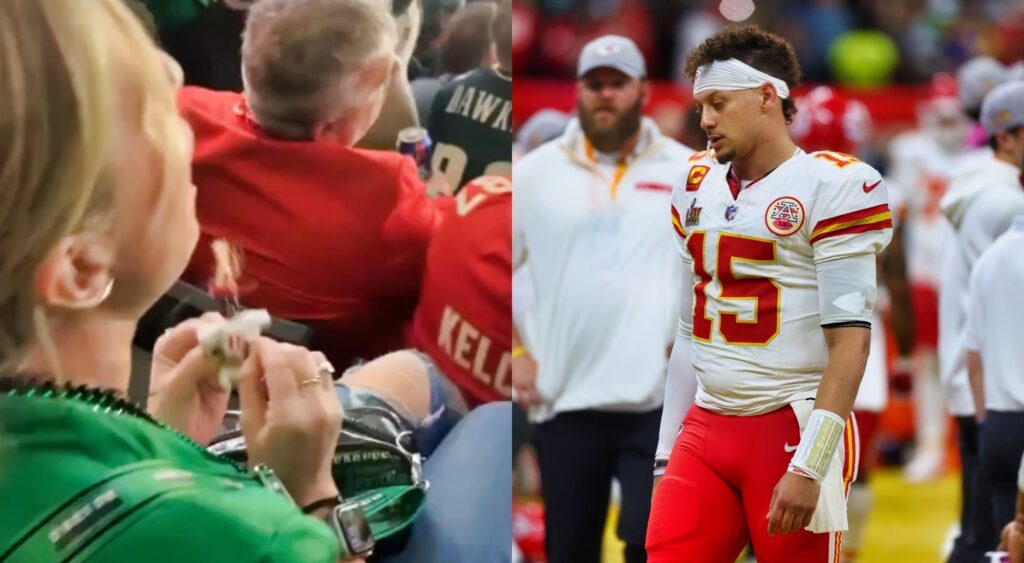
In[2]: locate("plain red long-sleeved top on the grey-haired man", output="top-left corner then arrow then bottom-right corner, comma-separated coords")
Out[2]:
178,87 -> 450,369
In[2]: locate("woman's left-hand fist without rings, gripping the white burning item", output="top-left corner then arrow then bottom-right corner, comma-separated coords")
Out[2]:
148,313 -> 234,445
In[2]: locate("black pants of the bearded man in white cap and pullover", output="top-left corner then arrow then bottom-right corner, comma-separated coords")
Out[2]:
536,408 -> 662,563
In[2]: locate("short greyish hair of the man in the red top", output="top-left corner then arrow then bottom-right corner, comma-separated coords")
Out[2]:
242,0 -> 397,139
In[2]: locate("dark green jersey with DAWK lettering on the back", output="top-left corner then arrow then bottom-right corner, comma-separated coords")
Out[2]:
428,69 -> 512,191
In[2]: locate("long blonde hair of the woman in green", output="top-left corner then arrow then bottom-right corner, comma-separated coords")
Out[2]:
0,0 -> 185,372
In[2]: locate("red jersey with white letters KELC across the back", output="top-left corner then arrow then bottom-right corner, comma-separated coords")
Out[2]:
413,176 -> 512,405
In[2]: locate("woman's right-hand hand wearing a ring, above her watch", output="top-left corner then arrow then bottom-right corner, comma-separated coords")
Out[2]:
239,338 -> 341,506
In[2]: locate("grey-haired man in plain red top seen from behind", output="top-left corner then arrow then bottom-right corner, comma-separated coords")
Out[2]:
178,0 -> 443,367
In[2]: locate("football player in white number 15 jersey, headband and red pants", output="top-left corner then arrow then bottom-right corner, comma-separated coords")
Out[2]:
647,27 -> 892,563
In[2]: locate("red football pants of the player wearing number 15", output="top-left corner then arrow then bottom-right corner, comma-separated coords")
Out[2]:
647,405 -> 858,563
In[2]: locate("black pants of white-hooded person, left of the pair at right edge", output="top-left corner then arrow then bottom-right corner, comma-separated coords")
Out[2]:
948,417 -> 995,563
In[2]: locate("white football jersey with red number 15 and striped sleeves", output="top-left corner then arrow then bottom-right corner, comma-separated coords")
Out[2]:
672,150 -> 892,416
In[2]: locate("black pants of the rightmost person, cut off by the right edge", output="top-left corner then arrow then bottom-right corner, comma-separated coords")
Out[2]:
981,410 -> 1024,531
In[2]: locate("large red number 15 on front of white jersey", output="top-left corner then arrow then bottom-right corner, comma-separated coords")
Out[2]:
686,231 -> 781,346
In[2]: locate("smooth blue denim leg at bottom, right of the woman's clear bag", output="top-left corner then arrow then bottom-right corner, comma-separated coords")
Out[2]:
375,401 -> 512,563
